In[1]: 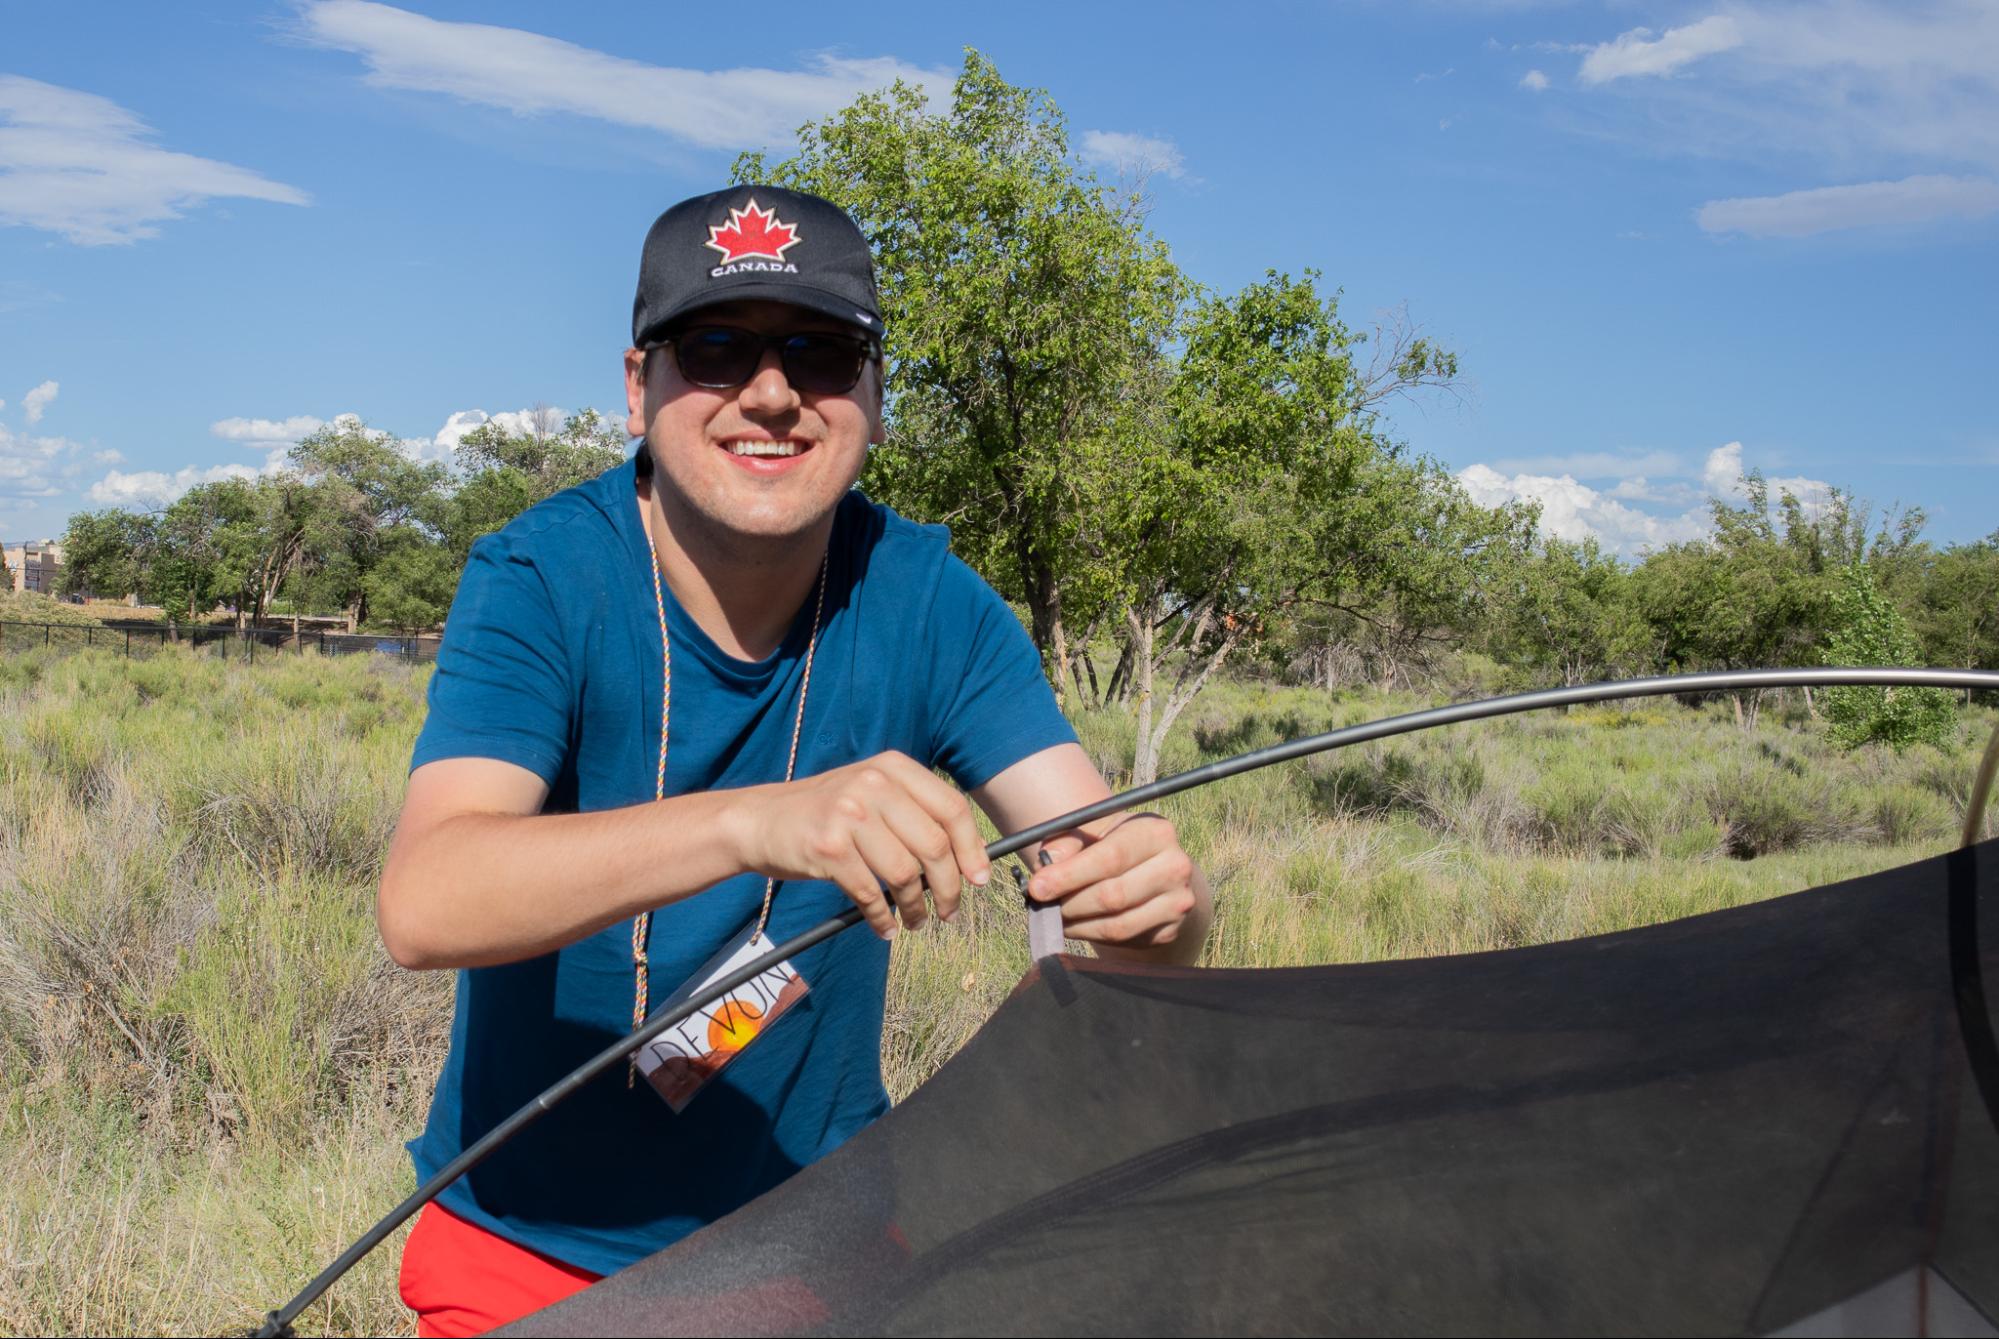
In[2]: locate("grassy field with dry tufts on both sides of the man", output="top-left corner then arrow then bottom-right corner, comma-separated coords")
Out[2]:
0,648 -> 1993,1333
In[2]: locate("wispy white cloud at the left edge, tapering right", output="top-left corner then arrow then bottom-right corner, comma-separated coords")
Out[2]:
0,74 -> 308,246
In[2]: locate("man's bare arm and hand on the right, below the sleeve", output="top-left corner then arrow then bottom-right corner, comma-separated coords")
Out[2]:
974,743 -> 1213,963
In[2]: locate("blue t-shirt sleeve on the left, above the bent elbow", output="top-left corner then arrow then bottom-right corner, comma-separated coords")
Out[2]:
410,536 -> 574,785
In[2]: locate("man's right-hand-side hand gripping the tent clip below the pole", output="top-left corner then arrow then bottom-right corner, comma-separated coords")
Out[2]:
1027,813 -> 1211,961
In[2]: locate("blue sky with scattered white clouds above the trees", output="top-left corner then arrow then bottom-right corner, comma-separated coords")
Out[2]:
0,0 -> 1999,554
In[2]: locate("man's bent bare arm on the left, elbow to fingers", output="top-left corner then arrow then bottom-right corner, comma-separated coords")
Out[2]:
376,753 -> 992,967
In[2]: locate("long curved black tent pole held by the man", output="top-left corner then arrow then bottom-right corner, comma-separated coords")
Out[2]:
254,670 -> 1999,1335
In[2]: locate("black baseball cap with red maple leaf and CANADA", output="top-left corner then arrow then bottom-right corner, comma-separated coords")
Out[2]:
632,186 -> 882,348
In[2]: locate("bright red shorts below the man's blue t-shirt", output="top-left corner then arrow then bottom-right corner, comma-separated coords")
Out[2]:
400,1201 -> 602,1339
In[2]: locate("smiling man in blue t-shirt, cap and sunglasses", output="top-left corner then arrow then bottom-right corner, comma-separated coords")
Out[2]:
378,186 -> 1211,1333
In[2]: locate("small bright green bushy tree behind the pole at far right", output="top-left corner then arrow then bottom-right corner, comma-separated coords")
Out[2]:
1825,562 -> 1957,751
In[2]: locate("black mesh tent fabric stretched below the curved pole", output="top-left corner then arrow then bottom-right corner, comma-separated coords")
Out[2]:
508,841 -> 1999,1335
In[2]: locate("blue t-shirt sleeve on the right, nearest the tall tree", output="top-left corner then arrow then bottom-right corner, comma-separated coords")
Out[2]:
930,556 -> 1075,789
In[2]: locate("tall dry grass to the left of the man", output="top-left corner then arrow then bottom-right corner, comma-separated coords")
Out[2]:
0,652 -> 450,1333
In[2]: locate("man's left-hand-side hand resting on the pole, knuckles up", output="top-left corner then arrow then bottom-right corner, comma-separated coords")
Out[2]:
738,753 -> 992,939
